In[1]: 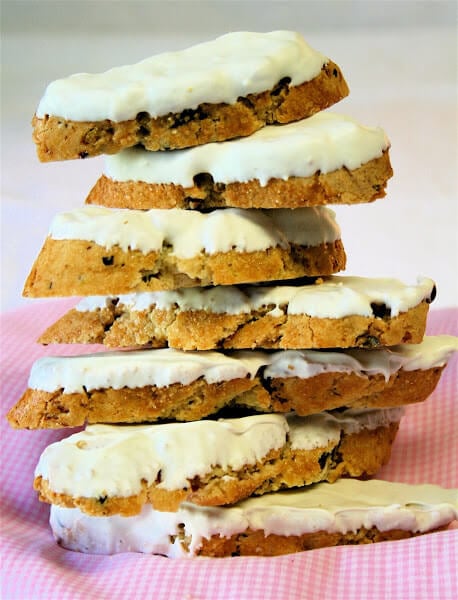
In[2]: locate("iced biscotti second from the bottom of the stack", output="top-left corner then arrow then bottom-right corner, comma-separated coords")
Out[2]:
34,408 -> 403,515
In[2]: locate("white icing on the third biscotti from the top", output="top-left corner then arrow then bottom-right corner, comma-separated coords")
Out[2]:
49,206 -> 340,258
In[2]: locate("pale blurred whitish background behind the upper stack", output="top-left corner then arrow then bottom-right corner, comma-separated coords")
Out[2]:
1,0 -> 458,310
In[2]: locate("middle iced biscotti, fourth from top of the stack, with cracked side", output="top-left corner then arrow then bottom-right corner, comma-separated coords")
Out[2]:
39,276 -> 435,350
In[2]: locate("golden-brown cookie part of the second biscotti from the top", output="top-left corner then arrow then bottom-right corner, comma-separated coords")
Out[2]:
86,152 -> 392,210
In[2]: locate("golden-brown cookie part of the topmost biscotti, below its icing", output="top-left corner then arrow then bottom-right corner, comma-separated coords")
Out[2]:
32,61 -> 349,162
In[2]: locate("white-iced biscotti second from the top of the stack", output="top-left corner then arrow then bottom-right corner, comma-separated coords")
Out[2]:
86,112 -> 392,209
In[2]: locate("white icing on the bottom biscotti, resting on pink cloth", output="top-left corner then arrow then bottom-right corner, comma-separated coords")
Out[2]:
50,479 -> 458,557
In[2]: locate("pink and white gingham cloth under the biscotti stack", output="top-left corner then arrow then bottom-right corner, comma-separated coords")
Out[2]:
0,300 -> 458,600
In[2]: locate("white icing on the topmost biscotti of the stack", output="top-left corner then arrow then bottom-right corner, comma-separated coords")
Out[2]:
36,31 -> 328,121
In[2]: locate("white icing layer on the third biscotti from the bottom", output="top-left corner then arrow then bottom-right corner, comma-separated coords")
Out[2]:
28,335 -> 458,394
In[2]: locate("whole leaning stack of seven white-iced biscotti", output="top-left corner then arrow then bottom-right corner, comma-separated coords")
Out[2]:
8,31 -> 457,556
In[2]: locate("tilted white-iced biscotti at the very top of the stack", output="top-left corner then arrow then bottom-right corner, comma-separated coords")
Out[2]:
32,31 -> 349,161
